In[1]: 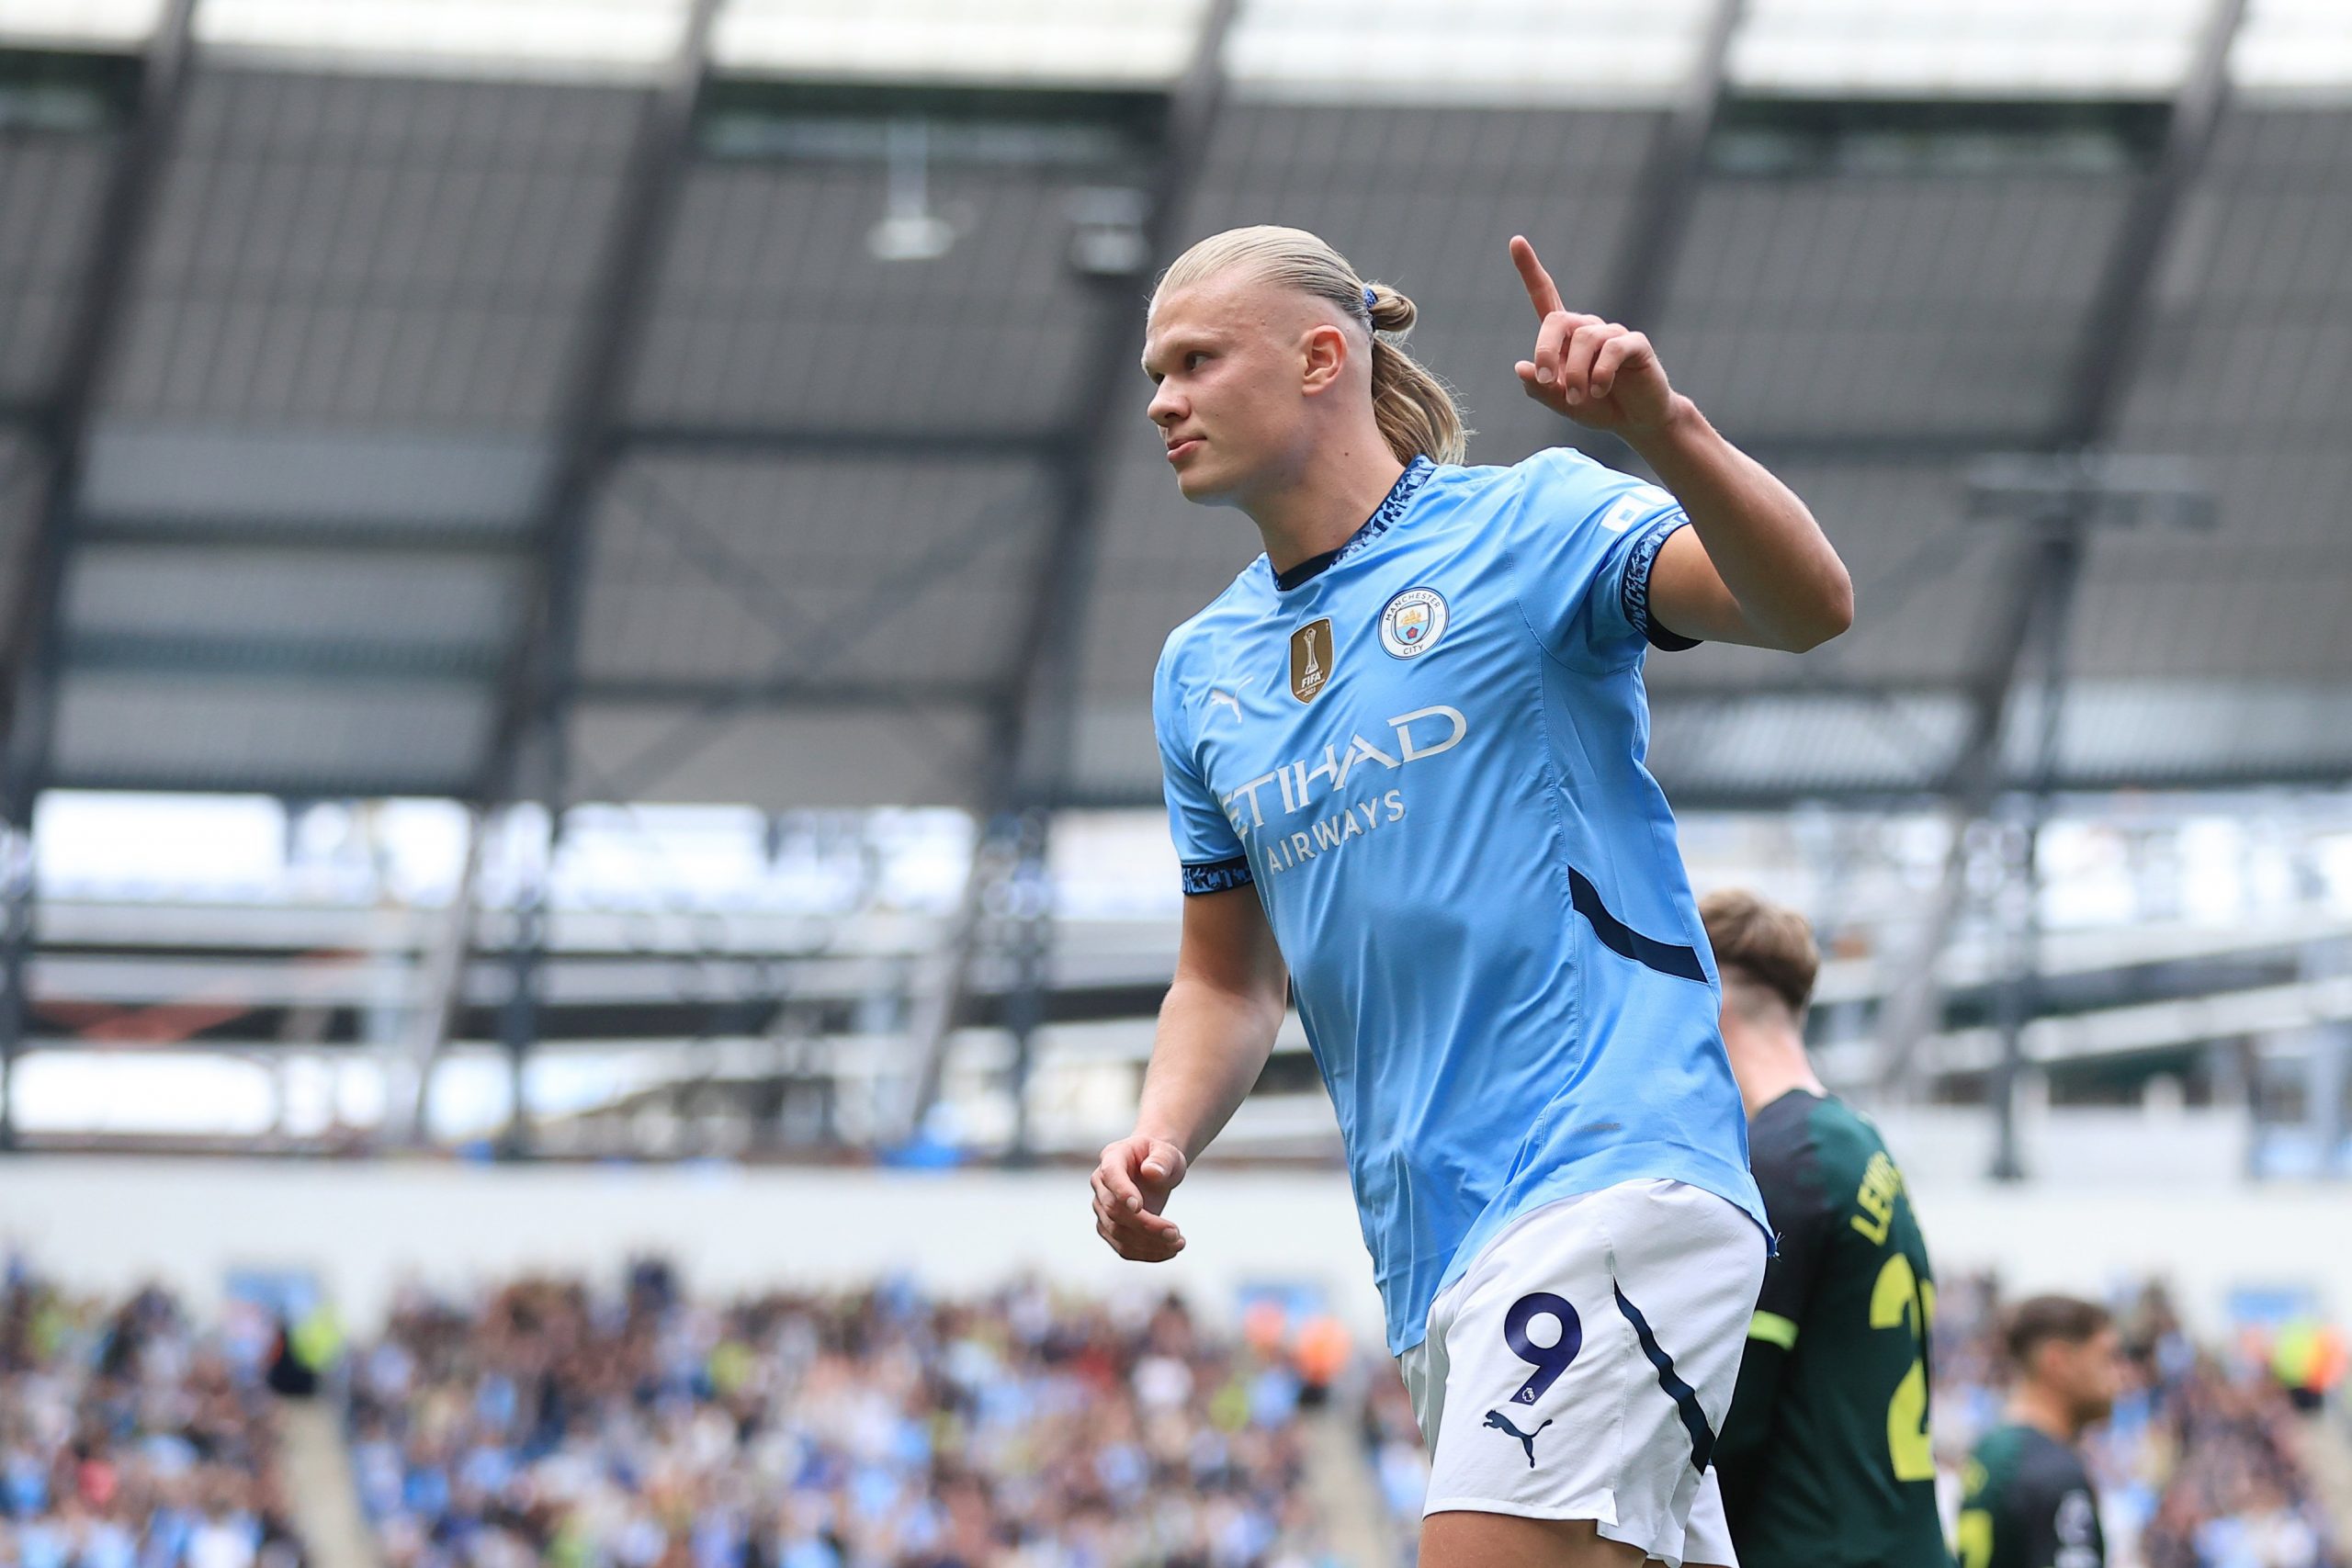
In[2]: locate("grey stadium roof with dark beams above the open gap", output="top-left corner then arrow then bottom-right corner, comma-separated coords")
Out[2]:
0,0 -> 2352,820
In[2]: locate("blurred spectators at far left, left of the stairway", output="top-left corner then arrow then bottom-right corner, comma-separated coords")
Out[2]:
0,1258 -> 303,1568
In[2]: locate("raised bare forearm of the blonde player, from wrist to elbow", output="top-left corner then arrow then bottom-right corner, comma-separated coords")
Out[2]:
1628,395 -> 1853,653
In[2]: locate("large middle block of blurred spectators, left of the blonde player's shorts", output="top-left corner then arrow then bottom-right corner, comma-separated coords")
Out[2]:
350,1265 -> 1329,1568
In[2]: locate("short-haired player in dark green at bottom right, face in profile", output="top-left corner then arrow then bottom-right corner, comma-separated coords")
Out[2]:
1959,1295 -> 2124,1568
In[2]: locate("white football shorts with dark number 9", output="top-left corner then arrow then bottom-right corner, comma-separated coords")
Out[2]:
1399,1180 -> 1767,1568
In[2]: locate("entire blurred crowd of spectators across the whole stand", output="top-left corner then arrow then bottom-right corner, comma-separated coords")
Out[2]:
0,1260 -> 2347,1568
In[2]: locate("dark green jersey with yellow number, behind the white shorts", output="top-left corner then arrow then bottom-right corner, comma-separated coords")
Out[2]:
1714,1090 -> 1952,1568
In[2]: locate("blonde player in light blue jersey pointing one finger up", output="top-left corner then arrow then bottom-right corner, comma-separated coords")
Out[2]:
1093,228 -> 1851,1568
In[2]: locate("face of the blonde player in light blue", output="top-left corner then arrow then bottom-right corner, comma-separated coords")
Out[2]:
1143,277 -> 1306,503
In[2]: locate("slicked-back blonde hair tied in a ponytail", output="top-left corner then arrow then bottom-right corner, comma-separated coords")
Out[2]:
1158,223 -> 1470,463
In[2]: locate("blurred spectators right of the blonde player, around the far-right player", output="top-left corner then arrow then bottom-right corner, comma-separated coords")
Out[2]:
1936,1277 -> 2345,1568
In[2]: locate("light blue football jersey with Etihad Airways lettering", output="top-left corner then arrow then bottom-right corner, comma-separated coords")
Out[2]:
1152,449 -> 1769,1354
